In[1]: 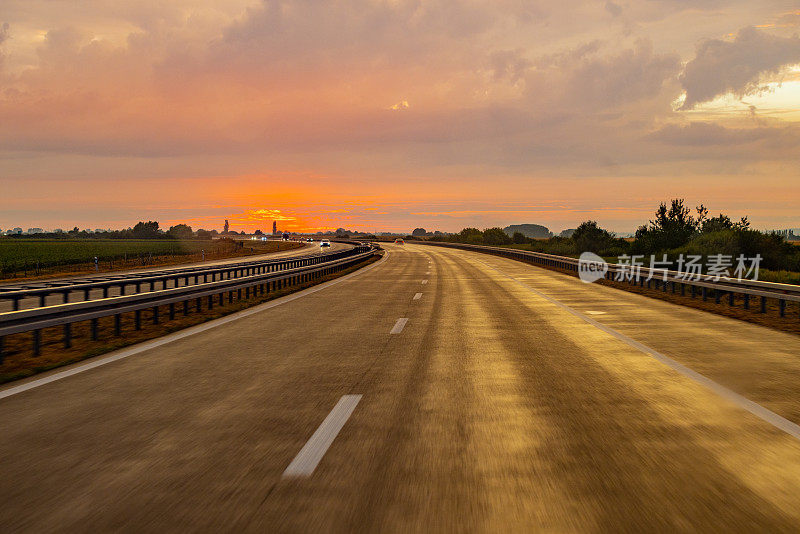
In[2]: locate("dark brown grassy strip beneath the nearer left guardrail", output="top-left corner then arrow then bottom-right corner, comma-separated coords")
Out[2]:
0,255 -> 380,384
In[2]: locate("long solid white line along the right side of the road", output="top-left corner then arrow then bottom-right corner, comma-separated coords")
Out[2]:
476,260 -> 800,439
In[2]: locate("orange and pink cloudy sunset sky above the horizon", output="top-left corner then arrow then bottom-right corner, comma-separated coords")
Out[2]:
0,0 -> 800,232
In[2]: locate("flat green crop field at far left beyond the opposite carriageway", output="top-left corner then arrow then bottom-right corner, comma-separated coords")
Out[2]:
0,238 -> 292,279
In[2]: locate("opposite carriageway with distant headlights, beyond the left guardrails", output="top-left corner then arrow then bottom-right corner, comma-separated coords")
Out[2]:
0,243 -> 351,313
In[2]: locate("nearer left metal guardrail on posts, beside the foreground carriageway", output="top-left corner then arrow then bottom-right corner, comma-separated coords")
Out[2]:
0,246 -> 376,363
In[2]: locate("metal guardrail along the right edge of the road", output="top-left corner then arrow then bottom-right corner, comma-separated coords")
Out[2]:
413,241 -> 800,317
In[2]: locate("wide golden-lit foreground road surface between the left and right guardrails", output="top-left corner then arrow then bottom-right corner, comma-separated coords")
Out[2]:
0,245 -> 800,532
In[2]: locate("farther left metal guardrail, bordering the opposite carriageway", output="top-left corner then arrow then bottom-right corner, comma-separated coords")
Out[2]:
0,245 -> 356,311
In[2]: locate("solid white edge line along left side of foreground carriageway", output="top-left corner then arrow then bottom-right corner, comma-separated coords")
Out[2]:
0,251 -> 389,399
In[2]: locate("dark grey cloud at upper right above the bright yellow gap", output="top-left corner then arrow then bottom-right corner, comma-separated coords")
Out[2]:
680,27 -> 800,109
